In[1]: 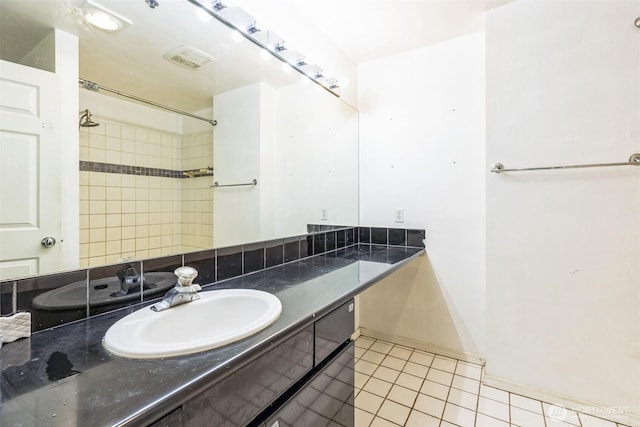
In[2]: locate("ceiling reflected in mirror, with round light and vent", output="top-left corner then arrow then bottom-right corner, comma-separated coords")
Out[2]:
0,0 -> 295,112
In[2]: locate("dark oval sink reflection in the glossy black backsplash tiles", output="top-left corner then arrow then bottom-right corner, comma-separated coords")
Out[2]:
33,272 -> 176,311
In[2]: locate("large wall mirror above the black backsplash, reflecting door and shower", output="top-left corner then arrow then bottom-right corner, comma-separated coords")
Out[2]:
0,0 -> 358,279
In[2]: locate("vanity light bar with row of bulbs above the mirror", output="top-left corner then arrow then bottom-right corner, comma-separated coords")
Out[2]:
188,0 -> 340,97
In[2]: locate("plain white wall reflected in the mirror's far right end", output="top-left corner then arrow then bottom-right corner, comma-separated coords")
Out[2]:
273,84 -> 358,236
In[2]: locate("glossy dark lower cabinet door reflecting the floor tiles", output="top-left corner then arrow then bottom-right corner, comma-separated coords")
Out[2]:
266,342 -> 355,427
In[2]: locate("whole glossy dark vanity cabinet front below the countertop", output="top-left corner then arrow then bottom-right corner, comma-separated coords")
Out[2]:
151,300 -> 354,427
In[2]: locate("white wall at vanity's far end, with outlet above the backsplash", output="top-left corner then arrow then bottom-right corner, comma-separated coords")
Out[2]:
359,33 -> 485,358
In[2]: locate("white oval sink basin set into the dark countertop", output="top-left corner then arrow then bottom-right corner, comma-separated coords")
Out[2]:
103,289 -> 282,359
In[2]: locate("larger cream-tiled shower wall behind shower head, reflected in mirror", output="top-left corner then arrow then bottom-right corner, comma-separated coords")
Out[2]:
80,118 -> 183,267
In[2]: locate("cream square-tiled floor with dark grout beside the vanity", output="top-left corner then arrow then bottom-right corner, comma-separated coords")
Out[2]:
355,337 -> 624,427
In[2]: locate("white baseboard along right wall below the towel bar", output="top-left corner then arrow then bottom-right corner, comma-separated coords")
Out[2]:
482,371 -> 640,427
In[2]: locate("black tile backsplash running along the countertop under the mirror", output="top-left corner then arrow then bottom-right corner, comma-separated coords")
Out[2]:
0,224 -> 426,332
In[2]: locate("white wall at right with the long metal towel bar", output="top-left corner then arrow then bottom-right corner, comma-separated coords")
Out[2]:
485,1 -> 640,422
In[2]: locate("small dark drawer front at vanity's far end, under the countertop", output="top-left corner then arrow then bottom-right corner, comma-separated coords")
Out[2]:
314,300 -> 355,365
